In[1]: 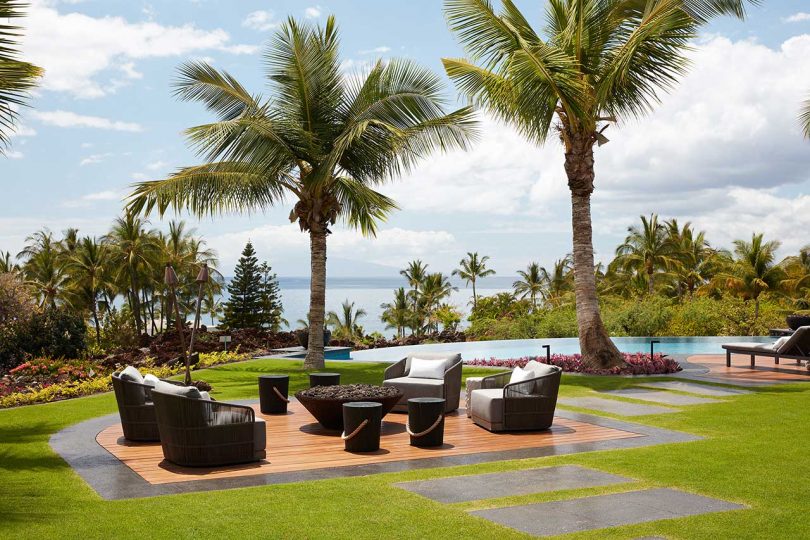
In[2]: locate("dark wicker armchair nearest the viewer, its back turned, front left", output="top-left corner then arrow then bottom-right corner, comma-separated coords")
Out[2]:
152,391 -> 267,467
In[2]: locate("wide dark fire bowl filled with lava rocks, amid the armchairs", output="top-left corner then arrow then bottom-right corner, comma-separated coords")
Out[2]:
295,384 -> 402,430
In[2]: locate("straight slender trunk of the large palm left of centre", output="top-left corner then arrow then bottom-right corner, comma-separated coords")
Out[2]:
304,224 -> 327,369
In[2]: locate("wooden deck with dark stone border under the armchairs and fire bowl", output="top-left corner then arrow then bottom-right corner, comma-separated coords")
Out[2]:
96,401 -> 643,484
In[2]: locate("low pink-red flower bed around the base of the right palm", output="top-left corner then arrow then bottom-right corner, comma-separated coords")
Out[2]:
465,353 -> 681,375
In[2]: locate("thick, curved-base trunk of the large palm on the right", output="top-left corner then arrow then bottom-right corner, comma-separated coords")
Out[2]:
565,132 -> 624,368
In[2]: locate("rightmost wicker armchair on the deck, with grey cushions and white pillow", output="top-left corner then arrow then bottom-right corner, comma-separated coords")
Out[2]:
471,366 -> 562,431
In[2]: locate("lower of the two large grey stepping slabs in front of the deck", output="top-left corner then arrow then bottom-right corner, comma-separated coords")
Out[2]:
471,489 -> 744,536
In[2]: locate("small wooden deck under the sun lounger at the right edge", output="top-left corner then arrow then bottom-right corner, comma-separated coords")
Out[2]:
689,354 -> 810,384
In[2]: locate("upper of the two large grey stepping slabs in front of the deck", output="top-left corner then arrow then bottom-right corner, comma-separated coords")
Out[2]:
394,465 -> 633,503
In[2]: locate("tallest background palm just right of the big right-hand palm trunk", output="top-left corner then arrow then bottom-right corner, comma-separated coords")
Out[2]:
614,214 -> 678,294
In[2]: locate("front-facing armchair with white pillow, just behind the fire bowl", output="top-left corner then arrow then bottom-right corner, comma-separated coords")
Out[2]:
383,354 -> 462,413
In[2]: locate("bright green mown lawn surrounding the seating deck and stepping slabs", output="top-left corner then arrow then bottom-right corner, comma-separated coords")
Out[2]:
0,360 -> 810,540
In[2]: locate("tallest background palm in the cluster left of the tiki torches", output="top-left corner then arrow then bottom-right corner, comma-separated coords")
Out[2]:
103,213 -> 160,335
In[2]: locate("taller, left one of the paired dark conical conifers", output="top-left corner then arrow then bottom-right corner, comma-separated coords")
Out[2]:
222,241 -> 263,328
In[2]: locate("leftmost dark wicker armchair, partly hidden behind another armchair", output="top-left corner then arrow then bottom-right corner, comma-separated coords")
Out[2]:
112,371 -> 181,441
